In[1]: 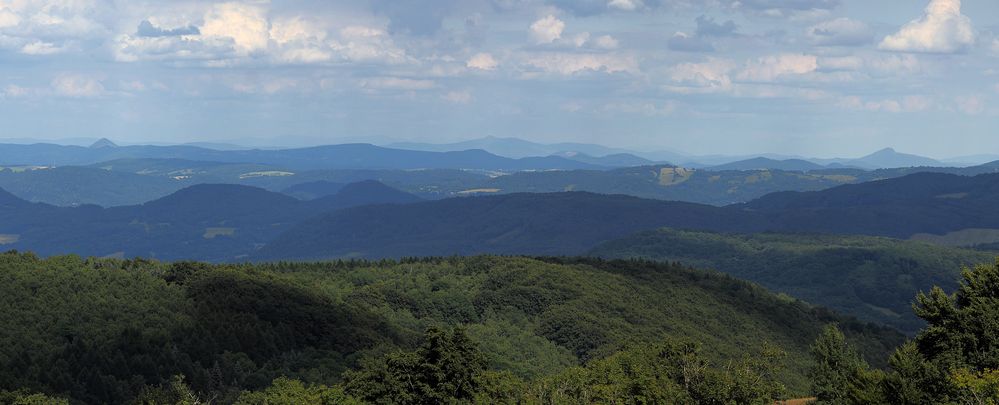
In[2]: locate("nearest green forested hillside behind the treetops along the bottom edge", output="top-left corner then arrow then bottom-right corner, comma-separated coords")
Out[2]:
0,253 -> 902,403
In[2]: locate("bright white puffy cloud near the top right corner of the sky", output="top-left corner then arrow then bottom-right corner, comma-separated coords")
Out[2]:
878,0 -> 975,53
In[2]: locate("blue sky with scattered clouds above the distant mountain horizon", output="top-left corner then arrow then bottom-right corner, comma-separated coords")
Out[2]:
0,0 -> 999,158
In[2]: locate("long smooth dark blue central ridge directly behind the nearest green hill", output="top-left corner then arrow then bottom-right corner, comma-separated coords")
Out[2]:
255,192 -> 763,260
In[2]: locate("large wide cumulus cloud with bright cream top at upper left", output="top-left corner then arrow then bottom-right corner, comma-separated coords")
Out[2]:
112,3 -> 410,66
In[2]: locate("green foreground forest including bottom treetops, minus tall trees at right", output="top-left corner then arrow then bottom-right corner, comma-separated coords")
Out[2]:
0,252 -> 904,404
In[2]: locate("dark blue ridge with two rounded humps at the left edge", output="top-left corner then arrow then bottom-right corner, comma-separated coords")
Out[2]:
0,181 -> 419,261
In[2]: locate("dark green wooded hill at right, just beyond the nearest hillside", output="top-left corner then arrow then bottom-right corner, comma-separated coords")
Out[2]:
590,229 -> 996,334
